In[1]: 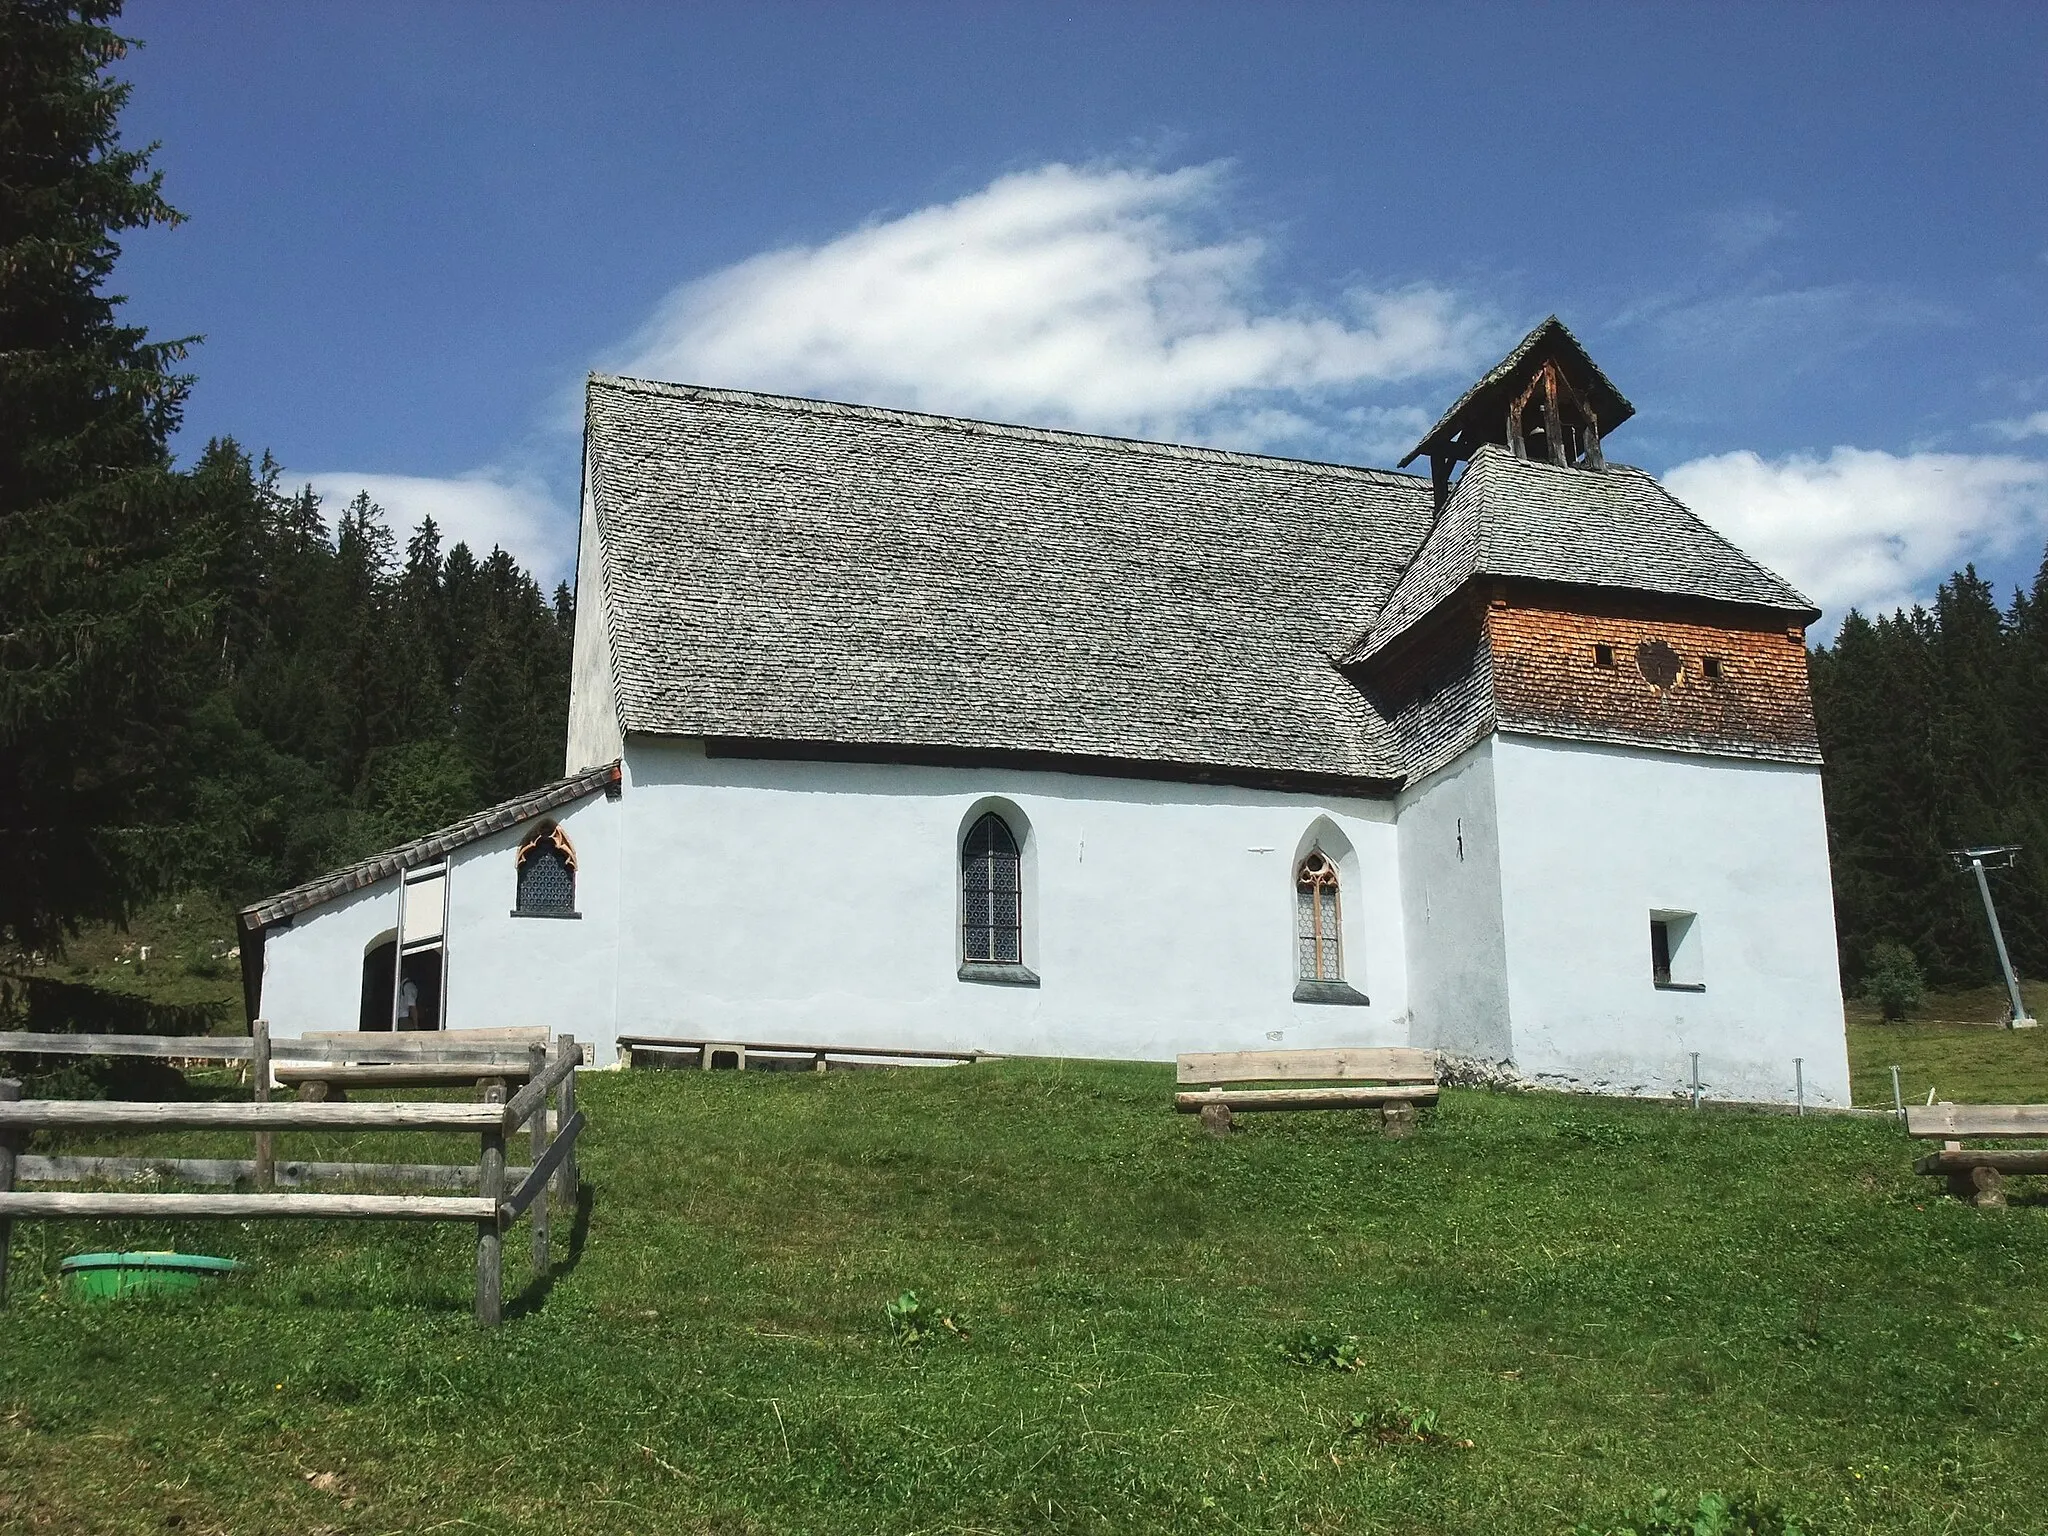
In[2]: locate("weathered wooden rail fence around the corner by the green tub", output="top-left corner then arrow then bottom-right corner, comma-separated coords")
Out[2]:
0,1022 -> 584,1327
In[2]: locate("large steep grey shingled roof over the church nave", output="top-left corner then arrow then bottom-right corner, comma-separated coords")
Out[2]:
588,377 -> 1432,788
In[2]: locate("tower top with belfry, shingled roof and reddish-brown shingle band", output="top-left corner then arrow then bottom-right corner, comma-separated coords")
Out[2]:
1339,315 -> 1819,774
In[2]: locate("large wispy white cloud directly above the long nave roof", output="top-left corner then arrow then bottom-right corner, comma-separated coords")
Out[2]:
612,164 -> 1499,446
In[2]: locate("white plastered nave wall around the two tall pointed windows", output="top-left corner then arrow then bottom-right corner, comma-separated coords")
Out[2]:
618,737 -> 1407,1061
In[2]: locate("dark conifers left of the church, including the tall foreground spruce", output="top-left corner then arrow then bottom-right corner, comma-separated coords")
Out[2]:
0,0 -> 571,946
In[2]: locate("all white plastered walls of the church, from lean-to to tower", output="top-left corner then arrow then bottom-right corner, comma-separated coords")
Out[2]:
251,735 -> 1847,1104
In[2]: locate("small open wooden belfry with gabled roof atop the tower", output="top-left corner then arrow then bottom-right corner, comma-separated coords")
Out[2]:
1401,315 -> 1636,508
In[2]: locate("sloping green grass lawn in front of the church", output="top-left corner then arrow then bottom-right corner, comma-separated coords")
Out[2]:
0,1056 -> 2048,1536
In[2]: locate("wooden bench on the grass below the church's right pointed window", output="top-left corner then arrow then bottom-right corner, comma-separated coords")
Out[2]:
1174,1044 -> 1438,1137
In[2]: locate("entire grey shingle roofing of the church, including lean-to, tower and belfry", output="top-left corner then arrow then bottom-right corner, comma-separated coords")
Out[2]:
242,342 -> 1819,932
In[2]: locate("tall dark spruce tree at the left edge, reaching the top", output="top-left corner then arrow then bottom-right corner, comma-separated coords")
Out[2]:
0,0 -> 213,942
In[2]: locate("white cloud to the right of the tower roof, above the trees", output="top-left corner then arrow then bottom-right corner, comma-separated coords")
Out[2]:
1663,449 -> 2048,623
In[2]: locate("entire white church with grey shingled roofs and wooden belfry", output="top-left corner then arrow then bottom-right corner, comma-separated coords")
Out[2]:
242,319 -> 1849,1104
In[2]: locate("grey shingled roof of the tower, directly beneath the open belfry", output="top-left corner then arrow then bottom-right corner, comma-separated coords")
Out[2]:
1343,444 -> 1821,662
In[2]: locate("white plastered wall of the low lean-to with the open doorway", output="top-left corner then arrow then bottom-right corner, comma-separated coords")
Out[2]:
262,795 -> 621,1053
